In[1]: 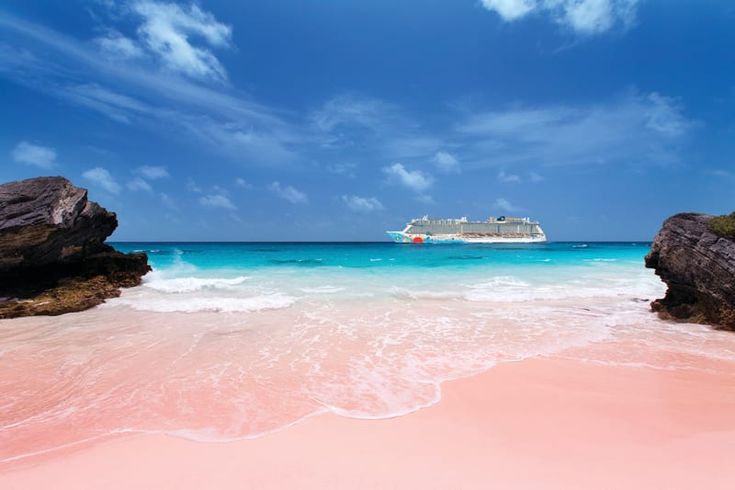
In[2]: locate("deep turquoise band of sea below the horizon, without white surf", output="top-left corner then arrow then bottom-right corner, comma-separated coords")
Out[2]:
112,242 -> 650,270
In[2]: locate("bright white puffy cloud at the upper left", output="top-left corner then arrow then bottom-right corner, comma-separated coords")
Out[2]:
131,0 -> 232,81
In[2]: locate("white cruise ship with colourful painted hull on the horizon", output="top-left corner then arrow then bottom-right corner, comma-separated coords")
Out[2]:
386,216 -> 546,243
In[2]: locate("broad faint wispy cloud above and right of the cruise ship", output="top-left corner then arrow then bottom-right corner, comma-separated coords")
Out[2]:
456,93 -> 697,167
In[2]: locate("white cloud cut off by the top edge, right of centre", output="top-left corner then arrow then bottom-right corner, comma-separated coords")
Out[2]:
482,0 -> 639,34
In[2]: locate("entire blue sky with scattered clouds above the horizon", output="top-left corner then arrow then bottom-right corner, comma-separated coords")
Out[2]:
0,0 -> 735,240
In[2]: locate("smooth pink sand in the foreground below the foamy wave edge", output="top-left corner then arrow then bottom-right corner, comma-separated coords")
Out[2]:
5,356 -> 735,489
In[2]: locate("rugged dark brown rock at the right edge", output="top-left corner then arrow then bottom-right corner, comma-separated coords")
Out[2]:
646,213 -> 735,330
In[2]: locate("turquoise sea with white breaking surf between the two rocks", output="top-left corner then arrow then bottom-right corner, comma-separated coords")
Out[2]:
105,242 -> 660,312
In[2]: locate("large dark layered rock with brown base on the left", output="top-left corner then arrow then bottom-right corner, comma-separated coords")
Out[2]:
0,177 -> 150,318
